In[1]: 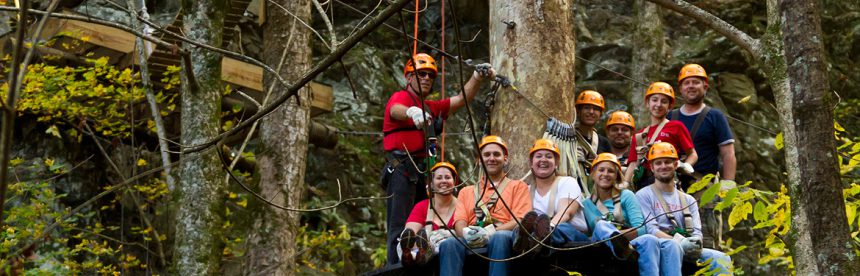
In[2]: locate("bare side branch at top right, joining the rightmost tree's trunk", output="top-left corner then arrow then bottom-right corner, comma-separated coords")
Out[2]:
647,0 -> 761,56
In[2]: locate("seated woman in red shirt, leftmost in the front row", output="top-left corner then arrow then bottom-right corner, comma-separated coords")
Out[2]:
397,162 -> 459,266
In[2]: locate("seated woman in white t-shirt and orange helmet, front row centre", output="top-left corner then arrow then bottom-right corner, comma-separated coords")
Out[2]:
514,139 -> 588,252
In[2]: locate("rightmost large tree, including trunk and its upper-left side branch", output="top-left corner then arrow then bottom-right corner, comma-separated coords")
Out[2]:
648,0 -> 860,275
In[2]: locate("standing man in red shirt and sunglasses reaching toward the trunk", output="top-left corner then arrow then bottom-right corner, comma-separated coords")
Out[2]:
381,53 -> 496,264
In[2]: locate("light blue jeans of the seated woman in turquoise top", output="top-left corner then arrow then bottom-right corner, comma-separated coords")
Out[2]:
591,220 -> 684,275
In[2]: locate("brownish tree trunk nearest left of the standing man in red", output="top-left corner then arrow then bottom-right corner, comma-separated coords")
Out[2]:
245,0 -> 311,275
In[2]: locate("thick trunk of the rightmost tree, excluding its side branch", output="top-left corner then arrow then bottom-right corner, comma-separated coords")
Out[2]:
777,0 -> 860,275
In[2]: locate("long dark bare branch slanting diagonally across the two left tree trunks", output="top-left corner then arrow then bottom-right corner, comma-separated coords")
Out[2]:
182,0 -> 409,153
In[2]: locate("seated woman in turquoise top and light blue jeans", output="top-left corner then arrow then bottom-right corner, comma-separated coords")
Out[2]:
583,153 -> 683,275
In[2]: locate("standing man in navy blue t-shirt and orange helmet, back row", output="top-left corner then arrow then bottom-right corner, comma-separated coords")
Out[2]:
669,64 -> 737,249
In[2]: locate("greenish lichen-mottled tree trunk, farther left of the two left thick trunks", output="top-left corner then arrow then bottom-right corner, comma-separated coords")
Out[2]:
174,0 -> 227,275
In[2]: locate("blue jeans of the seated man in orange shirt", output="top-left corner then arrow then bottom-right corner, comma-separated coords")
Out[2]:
439,230 -> 514,276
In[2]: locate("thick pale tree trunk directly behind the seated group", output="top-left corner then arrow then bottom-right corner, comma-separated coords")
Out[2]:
490,0 -> 576,177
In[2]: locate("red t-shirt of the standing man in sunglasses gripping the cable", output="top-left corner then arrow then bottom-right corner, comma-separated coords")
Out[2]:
382,90 -> 451,152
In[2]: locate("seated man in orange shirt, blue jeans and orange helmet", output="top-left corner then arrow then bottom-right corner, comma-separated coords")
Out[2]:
439,135 -> 532,275
